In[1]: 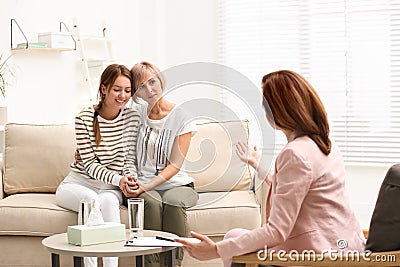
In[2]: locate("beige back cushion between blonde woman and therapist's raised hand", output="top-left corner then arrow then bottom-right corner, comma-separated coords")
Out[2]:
186,120 -> 253,192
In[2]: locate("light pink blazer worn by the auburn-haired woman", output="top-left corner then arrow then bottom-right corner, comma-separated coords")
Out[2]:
217,136 -> 365,260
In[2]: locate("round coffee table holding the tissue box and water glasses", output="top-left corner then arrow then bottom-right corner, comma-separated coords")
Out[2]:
42,230 -> 178,267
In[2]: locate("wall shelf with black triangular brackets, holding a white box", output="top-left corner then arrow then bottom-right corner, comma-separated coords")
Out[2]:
11,19 -> 76,52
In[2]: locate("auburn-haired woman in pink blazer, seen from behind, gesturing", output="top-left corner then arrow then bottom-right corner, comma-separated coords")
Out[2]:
177,70 -> 365,266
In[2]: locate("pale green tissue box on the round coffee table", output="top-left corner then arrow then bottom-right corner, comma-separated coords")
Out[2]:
67,222 -> 126,246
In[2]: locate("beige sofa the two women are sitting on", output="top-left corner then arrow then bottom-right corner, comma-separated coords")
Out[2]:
0,121 -> 265,266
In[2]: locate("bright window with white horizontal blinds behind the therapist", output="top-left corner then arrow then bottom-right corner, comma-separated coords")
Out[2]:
219,0 -> 400,166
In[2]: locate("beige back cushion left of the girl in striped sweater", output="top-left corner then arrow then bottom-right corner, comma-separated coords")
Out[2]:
3,124 -> 76,195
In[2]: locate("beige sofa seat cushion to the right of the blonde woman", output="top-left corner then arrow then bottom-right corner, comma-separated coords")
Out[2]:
187,190 -> 261,236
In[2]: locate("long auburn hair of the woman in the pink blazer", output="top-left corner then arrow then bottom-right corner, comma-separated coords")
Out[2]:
262,70 -> 331,155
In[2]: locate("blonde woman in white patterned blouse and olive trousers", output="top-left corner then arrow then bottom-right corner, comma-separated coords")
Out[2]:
124,62 -> 198,266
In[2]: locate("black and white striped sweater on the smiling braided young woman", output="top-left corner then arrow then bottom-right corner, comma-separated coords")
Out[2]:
71,107 -> 139,186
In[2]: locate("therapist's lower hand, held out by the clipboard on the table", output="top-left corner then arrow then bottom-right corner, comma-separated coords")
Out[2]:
175,231 -> 219,261
